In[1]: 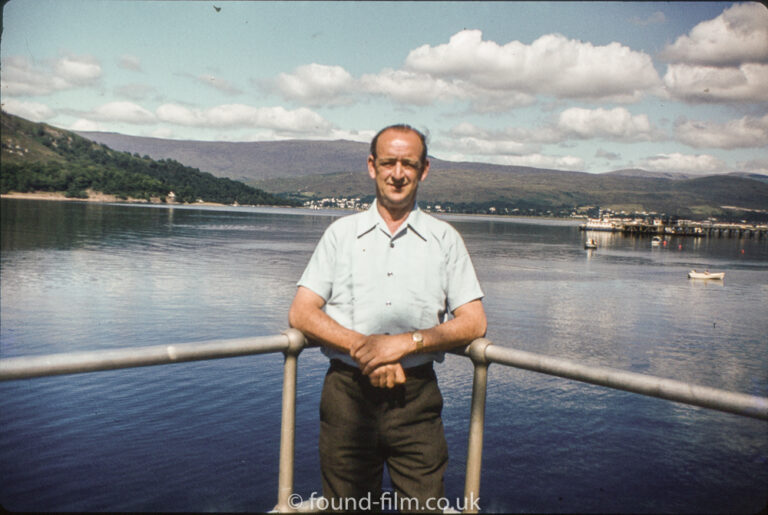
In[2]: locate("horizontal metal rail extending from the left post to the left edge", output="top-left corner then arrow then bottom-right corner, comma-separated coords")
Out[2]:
0,334 -> 290,381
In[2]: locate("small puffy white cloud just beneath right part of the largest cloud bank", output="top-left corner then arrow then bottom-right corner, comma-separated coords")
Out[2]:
557,107 -> 655,141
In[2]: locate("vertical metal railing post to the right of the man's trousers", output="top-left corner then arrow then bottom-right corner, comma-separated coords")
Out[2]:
463,338 -> 491,513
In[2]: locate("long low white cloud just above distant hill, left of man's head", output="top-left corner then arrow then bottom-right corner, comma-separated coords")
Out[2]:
156,104 -> 331,133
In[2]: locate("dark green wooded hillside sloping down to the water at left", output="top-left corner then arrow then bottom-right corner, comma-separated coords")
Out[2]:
0,112 -> 296,205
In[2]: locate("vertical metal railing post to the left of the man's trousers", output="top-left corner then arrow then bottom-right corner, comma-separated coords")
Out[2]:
275,329 -> 306,512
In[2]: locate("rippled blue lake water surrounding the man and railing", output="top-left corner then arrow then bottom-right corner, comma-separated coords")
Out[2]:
0,199 -> 768,513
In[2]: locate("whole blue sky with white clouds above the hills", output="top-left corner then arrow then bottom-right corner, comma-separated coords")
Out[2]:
0,0 -> 768,174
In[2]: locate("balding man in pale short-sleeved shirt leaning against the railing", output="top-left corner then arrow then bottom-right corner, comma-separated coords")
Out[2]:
289,125 -> 486,510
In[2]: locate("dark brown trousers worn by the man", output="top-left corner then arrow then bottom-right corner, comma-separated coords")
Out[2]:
320,360 -> 448,511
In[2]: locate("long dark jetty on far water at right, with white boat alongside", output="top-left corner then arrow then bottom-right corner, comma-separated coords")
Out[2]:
579,216 -> 768,239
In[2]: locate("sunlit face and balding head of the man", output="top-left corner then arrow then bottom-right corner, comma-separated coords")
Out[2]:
368,129 -> 429,213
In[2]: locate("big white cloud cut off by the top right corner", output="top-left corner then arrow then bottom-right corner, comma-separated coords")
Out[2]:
661,2 -> 768,66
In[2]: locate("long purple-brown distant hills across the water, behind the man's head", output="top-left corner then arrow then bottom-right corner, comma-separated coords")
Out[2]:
25,119 -> 768,218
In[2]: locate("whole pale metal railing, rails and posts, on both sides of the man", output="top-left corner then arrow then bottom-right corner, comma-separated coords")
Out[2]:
0,329 -> 768,512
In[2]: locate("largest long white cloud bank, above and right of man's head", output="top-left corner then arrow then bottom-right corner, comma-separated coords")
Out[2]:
274,30 -> 661,113
